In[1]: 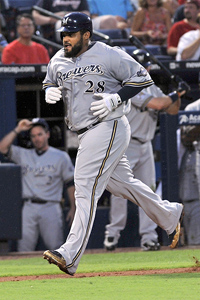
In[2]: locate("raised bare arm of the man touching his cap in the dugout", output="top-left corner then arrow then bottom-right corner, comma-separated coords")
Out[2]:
0,119 -> 32,154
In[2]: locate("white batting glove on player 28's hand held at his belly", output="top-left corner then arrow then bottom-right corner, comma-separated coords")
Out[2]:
90,93 -> 122,119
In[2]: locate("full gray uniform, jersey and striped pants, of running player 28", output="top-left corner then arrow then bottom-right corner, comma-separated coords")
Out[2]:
44,42 -> 182,274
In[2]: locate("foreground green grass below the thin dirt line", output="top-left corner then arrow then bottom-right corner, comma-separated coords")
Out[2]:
0,273 -> 200,300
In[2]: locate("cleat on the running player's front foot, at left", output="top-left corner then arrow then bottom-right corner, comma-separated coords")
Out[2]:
43,250 -> 73,276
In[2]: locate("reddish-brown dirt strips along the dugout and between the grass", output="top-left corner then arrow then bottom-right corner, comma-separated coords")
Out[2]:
0,247 -> 200,282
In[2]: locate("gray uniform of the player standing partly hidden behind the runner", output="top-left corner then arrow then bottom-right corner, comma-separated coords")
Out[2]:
105,85 -> 165,246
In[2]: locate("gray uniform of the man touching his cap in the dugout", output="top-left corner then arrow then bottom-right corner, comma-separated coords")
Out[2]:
9,145 -> 74,252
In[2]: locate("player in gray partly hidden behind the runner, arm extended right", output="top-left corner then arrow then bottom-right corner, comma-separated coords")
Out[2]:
104,50 -> 180,251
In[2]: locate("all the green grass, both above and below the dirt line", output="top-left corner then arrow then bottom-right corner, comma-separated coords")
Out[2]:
0,249 -> 200,300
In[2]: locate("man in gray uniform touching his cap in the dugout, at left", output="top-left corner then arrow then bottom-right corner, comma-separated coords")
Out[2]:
0,118 -> 75,252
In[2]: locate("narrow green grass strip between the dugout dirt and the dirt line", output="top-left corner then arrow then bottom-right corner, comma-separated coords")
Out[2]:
0,249 -> 200,277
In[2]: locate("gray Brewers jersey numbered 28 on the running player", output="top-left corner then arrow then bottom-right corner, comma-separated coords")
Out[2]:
43,42 -> 152,131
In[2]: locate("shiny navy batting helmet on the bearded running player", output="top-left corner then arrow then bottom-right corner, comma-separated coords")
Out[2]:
57,12 -> 92,39
